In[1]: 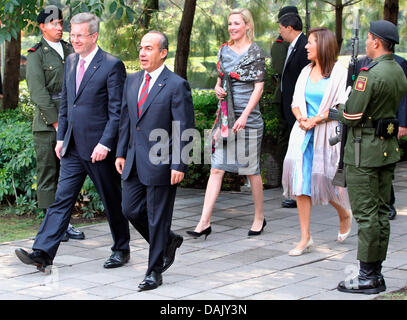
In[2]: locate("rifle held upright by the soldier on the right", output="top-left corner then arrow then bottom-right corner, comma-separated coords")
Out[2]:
328,12 -> 359,187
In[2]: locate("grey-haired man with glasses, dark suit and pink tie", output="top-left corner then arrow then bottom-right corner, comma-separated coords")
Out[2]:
16,13 -> 130,271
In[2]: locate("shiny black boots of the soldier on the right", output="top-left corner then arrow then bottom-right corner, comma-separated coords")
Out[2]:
337,261 -> 386,294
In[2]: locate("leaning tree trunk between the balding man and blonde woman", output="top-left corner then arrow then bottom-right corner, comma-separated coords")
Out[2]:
174,0 -> 196,80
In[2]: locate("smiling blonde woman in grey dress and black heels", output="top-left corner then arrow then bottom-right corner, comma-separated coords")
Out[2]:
187,9 -> 266,239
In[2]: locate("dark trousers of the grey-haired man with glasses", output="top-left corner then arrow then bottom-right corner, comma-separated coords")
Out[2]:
33,143 -> 130,259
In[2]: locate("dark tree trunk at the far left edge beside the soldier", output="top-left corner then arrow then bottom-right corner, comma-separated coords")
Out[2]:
3,33 -> 21,109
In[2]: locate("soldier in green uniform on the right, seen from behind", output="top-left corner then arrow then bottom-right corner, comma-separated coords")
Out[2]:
338,20 -> 407,294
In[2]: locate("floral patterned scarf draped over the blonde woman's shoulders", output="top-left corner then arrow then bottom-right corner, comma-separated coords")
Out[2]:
212,42 -> 266,152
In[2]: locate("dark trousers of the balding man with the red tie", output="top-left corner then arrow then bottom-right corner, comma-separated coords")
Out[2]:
122,167 -> 177,275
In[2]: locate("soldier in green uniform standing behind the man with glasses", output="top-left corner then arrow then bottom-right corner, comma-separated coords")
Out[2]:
26,6 -> 85,241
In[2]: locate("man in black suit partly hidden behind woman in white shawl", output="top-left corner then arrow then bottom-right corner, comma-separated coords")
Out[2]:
278,6 -> 310,208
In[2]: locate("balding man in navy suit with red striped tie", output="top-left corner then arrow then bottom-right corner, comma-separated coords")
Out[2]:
116,31 -> 194,290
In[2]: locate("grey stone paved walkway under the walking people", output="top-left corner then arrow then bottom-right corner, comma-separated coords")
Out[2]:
0,162 -> 407,300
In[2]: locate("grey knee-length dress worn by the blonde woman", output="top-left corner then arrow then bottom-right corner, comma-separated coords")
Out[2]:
211,44 -> 263,175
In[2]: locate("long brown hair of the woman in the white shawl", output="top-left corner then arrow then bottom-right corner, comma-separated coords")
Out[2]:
308,28 -> 339,78
